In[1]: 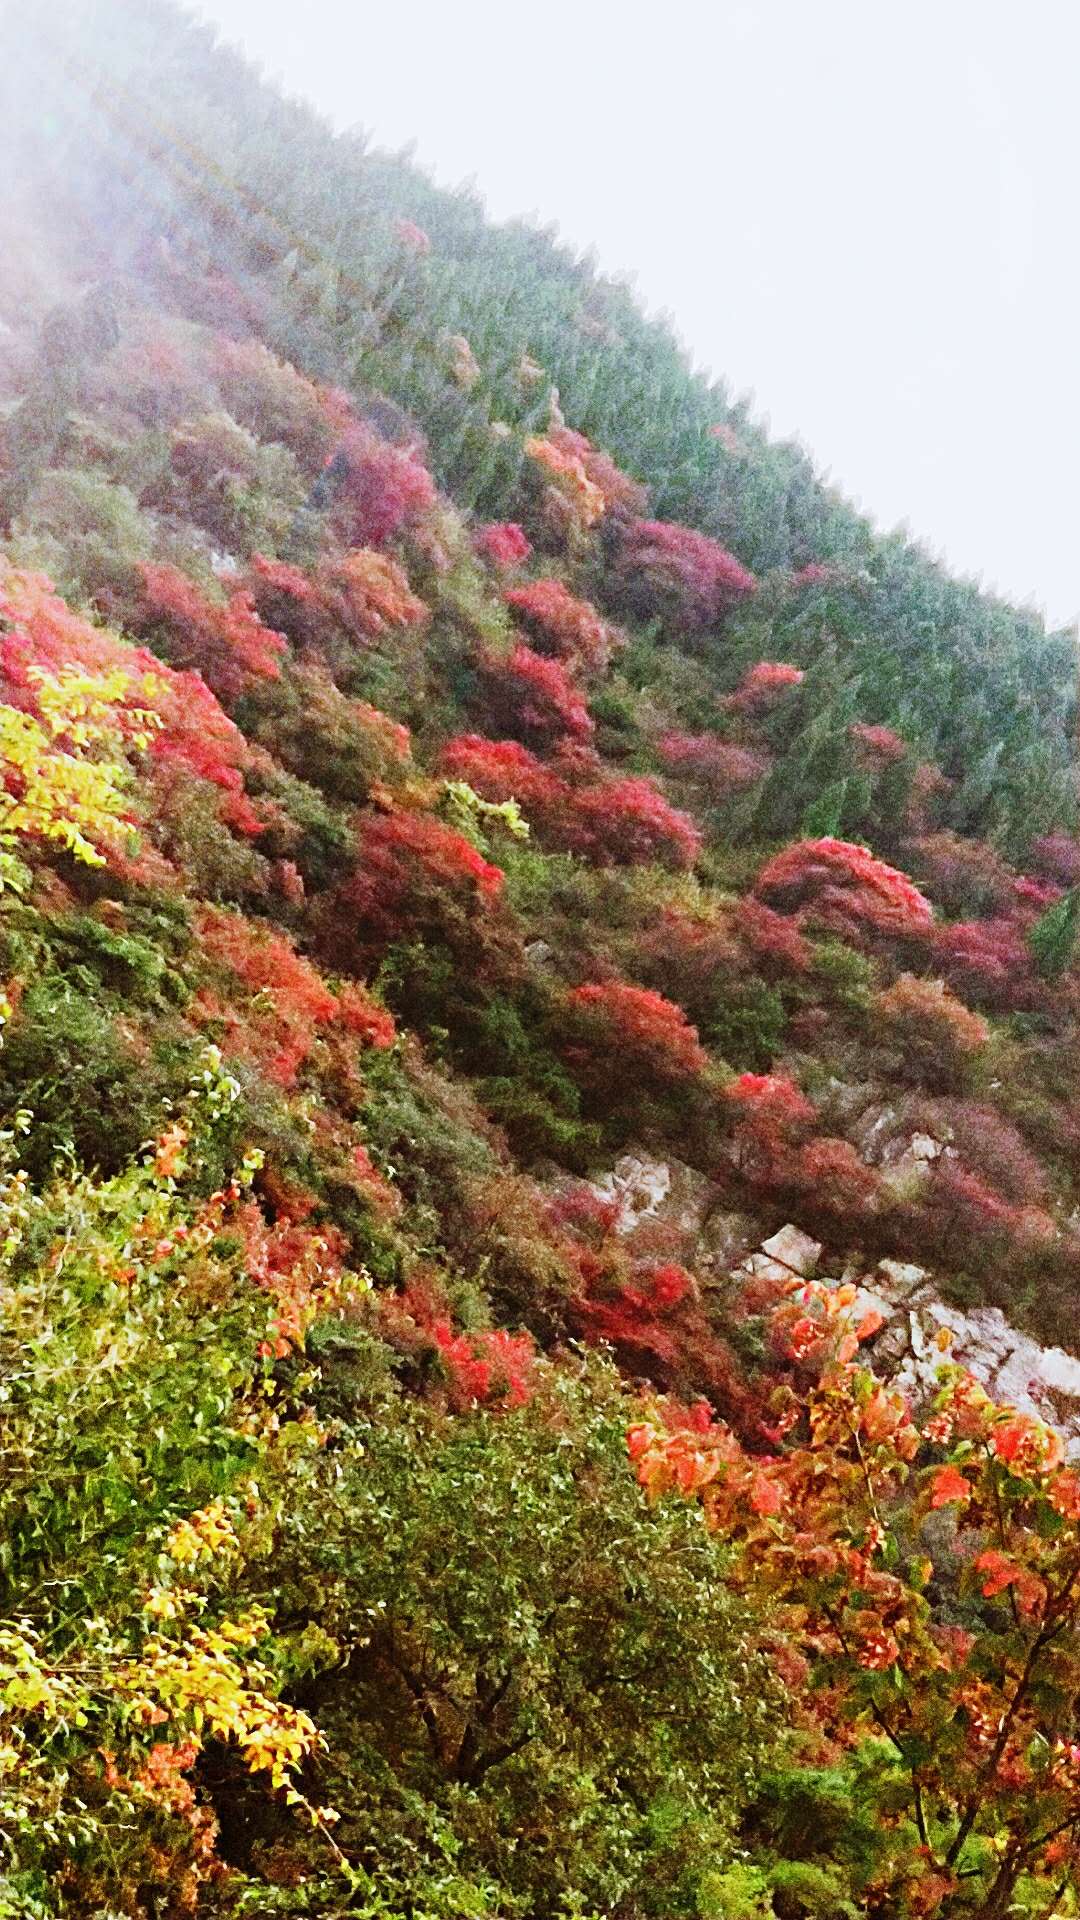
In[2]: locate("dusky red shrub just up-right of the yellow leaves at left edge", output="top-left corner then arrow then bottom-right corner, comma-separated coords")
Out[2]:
138,566 -> 288,701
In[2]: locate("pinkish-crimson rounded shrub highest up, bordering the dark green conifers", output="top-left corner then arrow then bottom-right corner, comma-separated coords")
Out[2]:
611,520 -> 757,628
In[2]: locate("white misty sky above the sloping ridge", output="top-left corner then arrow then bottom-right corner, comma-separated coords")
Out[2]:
189,0 -> 1080,620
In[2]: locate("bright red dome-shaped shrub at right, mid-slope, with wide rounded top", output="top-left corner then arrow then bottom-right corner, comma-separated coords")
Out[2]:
755,839 -> 934,937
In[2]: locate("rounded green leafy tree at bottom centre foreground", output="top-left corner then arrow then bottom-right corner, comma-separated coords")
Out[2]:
267,1363 -> 776,1914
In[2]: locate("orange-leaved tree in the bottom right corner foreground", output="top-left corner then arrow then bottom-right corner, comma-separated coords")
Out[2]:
630,1283 -> 1080,1920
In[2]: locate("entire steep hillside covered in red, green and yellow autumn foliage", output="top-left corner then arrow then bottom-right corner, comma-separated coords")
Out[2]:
0,0 -> 1080,1920
